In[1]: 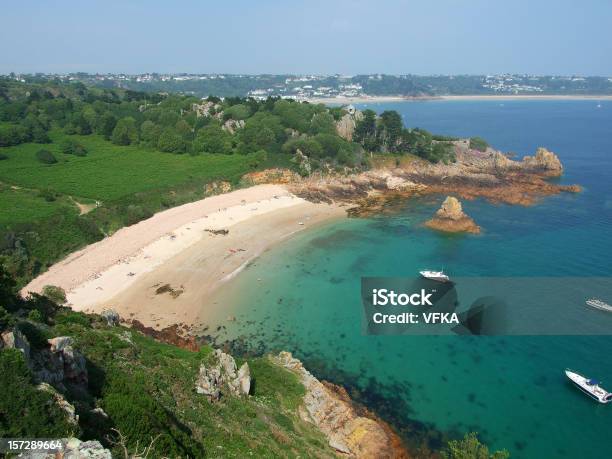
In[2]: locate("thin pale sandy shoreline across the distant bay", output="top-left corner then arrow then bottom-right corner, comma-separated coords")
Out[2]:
306,94 -> 612,105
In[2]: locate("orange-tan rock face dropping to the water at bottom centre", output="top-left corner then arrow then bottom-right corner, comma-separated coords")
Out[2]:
272,352 -> 407,458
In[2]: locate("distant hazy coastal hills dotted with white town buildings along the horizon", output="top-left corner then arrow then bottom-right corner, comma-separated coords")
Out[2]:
7,73 -> 612,100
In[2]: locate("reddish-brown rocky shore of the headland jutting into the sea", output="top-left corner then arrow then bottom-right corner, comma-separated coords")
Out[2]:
289,139 -> 581,214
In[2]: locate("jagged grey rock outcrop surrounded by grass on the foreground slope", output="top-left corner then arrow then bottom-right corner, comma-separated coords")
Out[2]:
196,349 -> 251,402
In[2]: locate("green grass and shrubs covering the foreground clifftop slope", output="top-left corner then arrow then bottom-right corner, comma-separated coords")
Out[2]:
0,265 -> 508,459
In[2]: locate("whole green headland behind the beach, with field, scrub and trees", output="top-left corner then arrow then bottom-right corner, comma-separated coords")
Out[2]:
0,78 -> 464,285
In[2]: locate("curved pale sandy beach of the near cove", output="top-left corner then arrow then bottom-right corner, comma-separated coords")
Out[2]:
21,185 -> 346,328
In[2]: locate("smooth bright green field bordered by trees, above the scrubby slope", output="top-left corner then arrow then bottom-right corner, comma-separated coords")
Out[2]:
0,132 -> 248,202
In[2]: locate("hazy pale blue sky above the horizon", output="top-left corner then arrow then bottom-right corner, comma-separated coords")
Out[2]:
0,0 -> 612,76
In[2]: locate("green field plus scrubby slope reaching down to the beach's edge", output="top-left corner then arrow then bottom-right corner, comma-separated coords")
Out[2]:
0,131 -> 256,285
